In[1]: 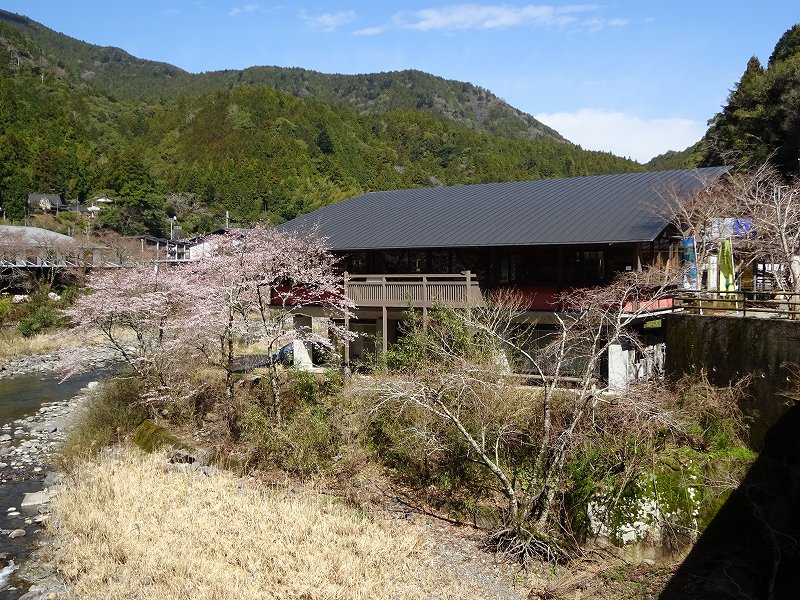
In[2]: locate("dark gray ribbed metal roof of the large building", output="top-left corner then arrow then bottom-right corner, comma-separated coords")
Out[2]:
280,167 -> 728,250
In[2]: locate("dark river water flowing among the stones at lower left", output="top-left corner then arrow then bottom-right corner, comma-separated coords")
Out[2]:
0,371 -> 100,600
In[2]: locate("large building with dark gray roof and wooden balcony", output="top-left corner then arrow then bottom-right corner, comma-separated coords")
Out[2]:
280,167 -> 727,382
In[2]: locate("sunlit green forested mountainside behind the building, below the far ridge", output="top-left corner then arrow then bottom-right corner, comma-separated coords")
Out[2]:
0,13 -> 641,234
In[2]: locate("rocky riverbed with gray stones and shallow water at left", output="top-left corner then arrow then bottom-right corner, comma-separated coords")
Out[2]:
0,349 -> 118,600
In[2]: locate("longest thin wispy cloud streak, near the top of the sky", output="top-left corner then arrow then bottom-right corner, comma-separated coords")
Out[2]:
355,3 -> 628,35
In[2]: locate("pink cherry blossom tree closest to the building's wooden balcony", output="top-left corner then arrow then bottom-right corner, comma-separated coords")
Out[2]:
182,227 -> 353,421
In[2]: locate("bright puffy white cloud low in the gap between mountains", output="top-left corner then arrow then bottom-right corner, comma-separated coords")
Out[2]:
534,108 -> 705,163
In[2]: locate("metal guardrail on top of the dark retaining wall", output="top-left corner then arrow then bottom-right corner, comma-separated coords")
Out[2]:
673,290 -> 800,319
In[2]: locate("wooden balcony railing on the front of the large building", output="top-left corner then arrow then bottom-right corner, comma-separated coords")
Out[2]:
344,271 -> 483,308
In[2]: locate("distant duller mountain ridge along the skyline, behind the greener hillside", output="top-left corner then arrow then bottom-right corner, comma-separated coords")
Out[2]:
0,11 -> 565,141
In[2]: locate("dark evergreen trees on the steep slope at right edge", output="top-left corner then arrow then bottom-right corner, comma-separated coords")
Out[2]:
698,24 -> 800,175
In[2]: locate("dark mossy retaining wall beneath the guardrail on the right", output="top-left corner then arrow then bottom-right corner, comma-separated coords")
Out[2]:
666,313 -> 800,449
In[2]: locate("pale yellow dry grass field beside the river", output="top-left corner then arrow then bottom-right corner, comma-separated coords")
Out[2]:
51,451 -> 500,600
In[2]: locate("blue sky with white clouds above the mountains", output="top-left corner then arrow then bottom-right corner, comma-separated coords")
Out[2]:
0,0 -> 800,161
